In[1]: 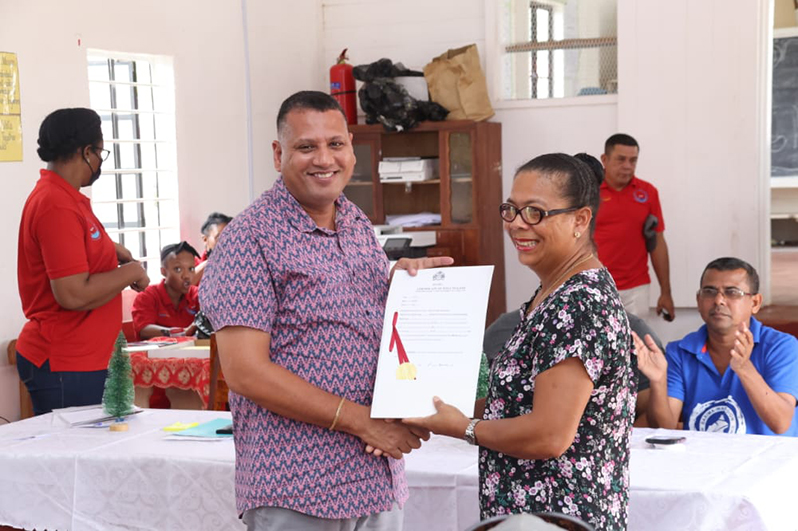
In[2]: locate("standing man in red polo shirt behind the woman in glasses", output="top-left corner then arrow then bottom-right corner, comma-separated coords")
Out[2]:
595,133 -> 676,321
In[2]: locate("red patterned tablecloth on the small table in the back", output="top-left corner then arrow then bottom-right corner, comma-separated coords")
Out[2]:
130,352 -> 211,408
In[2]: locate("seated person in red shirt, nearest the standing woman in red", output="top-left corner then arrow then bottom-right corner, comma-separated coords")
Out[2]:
132,242 -> 199,340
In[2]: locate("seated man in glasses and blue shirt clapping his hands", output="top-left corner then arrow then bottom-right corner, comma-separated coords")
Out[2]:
635,258 -> 798,436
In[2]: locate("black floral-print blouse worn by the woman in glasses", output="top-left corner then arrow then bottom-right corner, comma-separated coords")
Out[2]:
479,269 -> 637,530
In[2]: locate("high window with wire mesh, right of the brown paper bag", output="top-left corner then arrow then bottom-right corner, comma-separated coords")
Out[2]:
499,0 -> 618,100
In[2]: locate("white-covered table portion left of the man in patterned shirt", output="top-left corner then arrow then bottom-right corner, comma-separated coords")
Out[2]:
0,410 -> 245,531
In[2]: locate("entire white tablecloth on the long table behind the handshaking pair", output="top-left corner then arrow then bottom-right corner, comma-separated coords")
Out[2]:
0,416 -> 798,531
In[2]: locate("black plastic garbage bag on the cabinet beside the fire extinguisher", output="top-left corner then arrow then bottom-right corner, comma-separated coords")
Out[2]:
352,59 -> 449,131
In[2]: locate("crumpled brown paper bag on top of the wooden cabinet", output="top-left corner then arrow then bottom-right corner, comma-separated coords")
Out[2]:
424,44 -> 493,121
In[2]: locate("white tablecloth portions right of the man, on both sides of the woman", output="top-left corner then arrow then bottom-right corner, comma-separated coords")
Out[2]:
405,429 -> 798,531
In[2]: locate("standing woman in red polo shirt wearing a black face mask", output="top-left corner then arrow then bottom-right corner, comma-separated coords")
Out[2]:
17,108 -> 150,415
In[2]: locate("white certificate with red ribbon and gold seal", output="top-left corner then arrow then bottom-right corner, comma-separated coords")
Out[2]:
371,266 -> 493,418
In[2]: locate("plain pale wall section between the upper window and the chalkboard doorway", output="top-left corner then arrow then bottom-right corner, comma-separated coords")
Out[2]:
618,0 -> 771,306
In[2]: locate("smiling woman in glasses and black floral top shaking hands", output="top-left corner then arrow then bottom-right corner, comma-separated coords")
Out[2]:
405,154 -> 636,530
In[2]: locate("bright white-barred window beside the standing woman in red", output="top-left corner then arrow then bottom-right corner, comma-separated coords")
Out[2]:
88,51 -> 180,279
